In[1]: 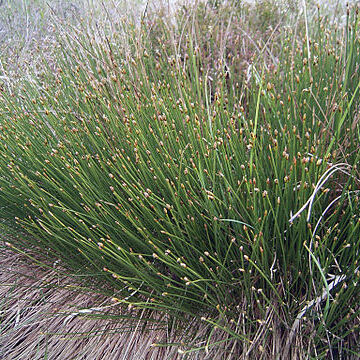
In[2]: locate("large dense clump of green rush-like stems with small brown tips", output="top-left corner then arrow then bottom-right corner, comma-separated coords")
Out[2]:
0,2 -> 360,358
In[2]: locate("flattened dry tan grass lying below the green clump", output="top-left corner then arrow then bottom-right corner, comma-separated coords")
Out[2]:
0,248 -> 240,360
